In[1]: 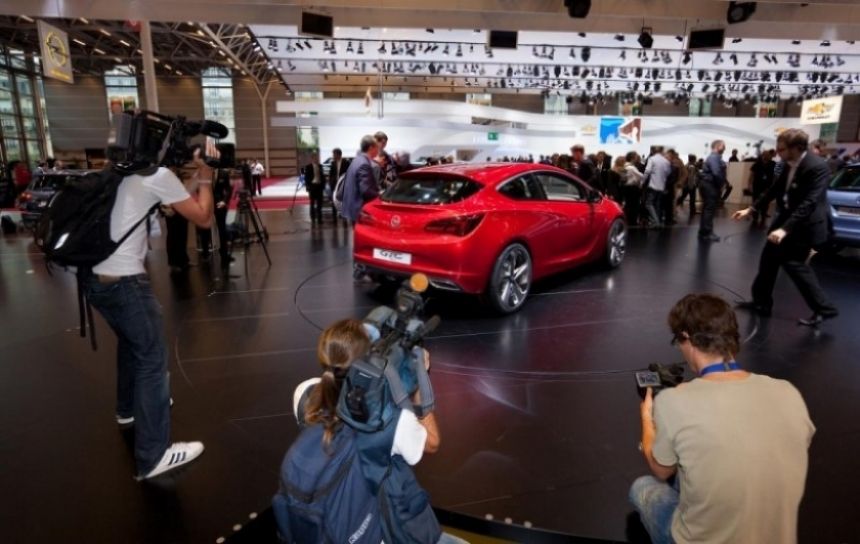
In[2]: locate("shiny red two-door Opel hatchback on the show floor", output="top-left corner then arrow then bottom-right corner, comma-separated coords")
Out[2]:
354,163 -> 627,313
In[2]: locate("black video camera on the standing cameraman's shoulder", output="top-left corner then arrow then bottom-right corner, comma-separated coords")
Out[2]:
107,110 -> 236,173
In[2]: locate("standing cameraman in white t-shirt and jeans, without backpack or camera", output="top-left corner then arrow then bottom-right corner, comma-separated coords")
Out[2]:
83,140 -> 219,480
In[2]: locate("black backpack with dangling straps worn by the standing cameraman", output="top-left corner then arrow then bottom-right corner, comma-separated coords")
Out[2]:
34,167 -> 158,349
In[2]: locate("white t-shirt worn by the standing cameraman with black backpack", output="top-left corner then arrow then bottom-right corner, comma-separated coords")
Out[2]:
93,167 -> 190,276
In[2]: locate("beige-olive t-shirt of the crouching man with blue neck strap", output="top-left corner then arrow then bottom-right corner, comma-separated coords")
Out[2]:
653,374 -> 815,544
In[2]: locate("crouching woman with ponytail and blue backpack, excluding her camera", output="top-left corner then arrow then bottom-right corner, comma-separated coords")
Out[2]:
280,319 -> 463,544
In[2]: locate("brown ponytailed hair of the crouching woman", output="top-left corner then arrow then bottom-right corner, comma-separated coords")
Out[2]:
305,319 -> 370,447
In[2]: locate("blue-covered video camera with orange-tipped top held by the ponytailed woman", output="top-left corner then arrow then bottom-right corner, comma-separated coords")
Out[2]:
337,274 -> 439,432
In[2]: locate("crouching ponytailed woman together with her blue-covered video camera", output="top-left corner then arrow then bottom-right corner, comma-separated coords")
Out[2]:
272,278 -> 463,544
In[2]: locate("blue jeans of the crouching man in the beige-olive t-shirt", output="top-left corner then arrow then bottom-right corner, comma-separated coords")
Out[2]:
630,476 -> 681,544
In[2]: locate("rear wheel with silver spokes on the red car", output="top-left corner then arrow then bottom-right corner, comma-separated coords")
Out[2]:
485,243 -> 532,314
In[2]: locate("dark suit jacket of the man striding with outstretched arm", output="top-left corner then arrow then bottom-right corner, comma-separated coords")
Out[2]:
755,152 -> 830,246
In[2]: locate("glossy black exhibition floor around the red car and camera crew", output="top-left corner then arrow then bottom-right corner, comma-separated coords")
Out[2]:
0,209 -> 860,543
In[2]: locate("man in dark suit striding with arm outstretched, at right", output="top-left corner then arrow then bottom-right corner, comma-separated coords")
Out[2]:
732,129 -> 839,327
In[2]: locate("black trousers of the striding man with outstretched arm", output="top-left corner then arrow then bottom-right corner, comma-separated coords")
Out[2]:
752,240 -> 836,313
